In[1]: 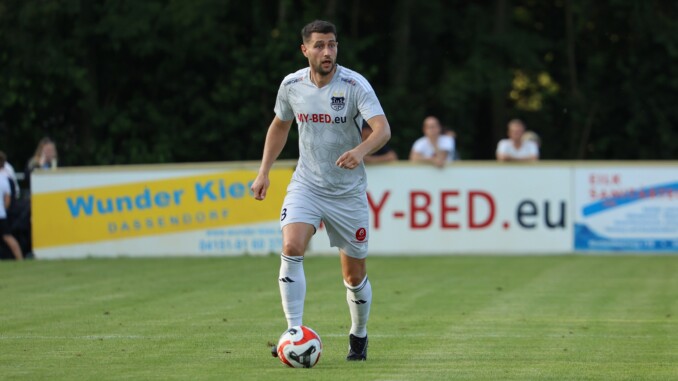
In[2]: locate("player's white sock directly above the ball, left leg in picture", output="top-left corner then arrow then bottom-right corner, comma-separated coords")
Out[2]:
278,254 -> 306,328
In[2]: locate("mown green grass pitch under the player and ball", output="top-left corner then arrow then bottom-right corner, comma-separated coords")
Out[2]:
0,252 -> 678,381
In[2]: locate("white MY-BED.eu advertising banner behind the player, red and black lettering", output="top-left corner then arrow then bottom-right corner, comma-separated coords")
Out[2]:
312,164 -> 572,255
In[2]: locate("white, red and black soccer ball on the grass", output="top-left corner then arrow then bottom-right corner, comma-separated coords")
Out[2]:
278,325 -> 323,368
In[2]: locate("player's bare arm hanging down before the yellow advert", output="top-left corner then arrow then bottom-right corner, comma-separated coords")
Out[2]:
251,116 -> 294,200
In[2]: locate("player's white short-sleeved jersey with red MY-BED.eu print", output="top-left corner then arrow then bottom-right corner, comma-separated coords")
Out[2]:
274,65 -> 384,196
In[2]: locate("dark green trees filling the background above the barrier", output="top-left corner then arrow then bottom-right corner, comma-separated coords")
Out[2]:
0,0 -> 678,168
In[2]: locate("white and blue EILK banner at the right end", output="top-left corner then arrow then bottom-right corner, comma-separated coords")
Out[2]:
574,166 -> 678,252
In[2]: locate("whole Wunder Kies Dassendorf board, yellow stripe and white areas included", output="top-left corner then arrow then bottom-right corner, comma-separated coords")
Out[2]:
31,166 -> 292,258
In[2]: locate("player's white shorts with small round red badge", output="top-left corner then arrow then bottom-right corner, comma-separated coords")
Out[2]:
280,186 -> 370,259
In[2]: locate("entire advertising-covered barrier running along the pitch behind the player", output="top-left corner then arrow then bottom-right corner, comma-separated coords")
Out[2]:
31,161 -> 678,258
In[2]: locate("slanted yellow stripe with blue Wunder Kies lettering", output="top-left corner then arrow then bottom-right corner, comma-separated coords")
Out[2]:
32,168 -> 293,249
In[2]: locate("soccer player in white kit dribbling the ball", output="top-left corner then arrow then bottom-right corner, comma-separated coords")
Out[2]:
252,20 -> 391,361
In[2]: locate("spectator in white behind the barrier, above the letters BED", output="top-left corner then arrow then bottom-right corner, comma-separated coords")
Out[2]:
410,116 -> 454,168
